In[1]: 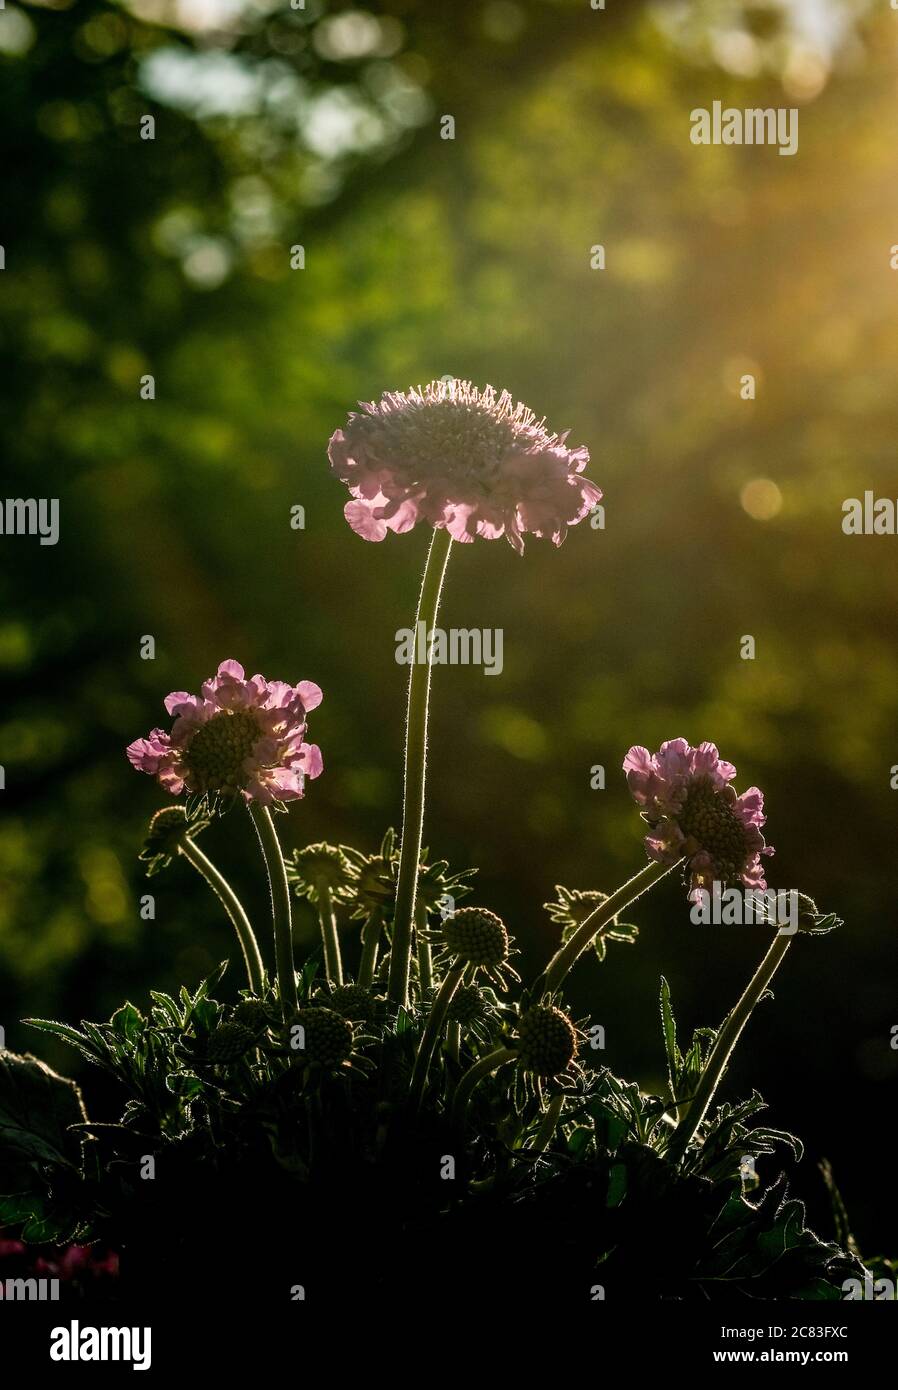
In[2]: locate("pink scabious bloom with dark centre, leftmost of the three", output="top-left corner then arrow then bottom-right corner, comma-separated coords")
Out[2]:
126,662 -> 323,806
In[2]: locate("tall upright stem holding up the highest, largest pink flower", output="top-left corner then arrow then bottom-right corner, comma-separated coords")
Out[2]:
388,527 -> 452,1006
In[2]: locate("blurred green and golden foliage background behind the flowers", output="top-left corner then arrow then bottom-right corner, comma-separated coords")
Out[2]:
0,0 -> 898,1254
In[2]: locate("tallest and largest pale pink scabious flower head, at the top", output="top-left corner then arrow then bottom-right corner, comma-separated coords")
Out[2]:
328,381 -> 602,555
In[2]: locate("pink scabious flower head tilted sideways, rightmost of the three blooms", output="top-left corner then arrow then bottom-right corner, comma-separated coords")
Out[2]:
624,738 -> 773,897
